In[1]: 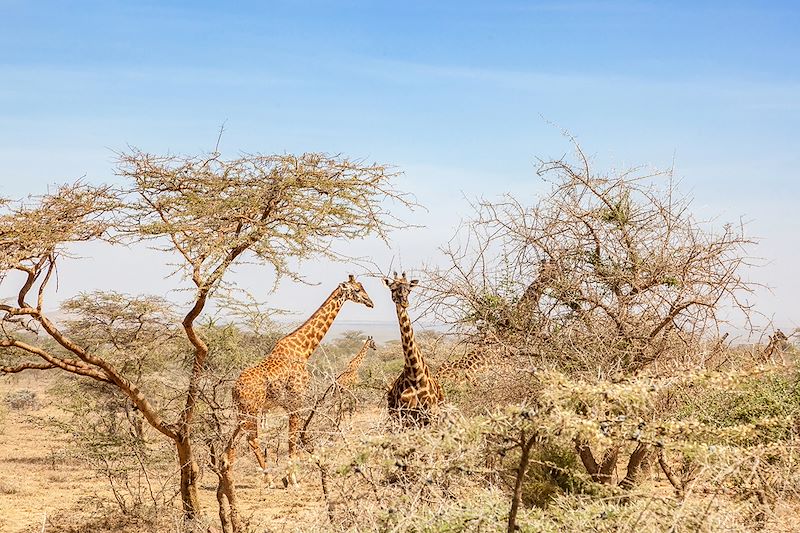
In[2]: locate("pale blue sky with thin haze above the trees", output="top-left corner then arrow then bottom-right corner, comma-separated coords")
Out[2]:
0,0 -> 800,327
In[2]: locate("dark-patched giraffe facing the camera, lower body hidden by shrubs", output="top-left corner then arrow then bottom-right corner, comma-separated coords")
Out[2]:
383,272 -> 444,424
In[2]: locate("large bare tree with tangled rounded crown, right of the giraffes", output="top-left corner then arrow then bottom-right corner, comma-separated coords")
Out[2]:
427,140 -> 751,486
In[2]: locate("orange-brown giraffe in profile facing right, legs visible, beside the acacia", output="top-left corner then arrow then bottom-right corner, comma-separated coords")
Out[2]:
232,274 -> 373,484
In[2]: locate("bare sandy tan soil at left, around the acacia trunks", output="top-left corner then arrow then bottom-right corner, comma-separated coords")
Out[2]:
0,374 -> 377,533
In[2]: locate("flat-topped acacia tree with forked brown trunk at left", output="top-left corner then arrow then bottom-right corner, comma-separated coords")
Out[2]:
0,149 -> 413,519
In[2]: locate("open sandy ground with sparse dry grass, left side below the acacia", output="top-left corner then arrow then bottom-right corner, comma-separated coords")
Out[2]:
0,362 -> 385,532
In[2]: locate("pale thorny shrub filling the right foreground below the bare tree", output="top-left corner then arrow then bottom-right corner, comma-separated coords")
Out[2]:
300,360 -> 800,531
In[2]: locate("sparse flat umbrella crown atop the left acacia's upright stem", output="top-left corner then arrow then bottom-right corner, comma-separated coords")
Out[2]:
118,149 -> 414,285
